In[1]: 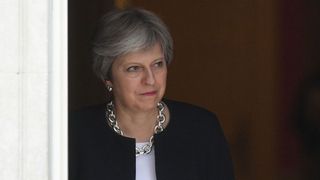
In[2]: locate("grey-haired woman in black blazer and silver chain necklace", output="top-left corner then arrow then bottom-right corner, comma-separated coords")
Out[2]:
69,9 -> 234,180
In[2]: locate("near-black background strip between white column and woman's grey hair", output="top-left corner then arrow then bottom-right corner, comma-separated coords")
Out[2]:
68,0 -> 113,110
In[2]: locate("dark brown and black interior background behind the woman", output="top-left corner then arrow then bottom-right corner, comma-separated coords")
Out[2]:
69,0 -> 320,180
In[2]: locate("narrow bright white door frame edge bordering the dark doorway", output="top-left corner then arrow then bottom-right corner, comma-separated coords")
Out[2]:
48,0 -> 68,180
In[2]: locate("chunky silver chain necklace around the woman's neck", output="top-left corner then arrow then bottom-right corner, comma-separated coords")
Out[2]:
106,101 -> 166,156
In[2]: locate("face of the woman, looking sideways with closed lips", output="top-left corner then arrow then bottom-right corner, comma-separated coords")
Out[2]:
106,43 -> 167,111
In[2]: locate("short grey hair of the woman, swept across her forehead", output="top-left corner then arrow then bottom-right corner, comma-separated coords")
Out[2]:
93,8 -> 173,80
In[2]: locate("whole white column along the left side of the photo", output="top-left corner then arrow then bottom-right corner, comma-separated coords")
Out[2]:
0,0 -> 67,180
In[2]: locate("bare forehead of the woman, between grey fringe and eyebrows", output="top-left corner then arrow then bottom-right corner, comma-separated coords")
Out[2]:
114,43 -> 164,65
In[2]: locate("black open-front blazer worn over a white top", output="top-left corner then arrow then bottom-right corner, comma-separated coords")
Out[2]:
69,100 -> 234,180
